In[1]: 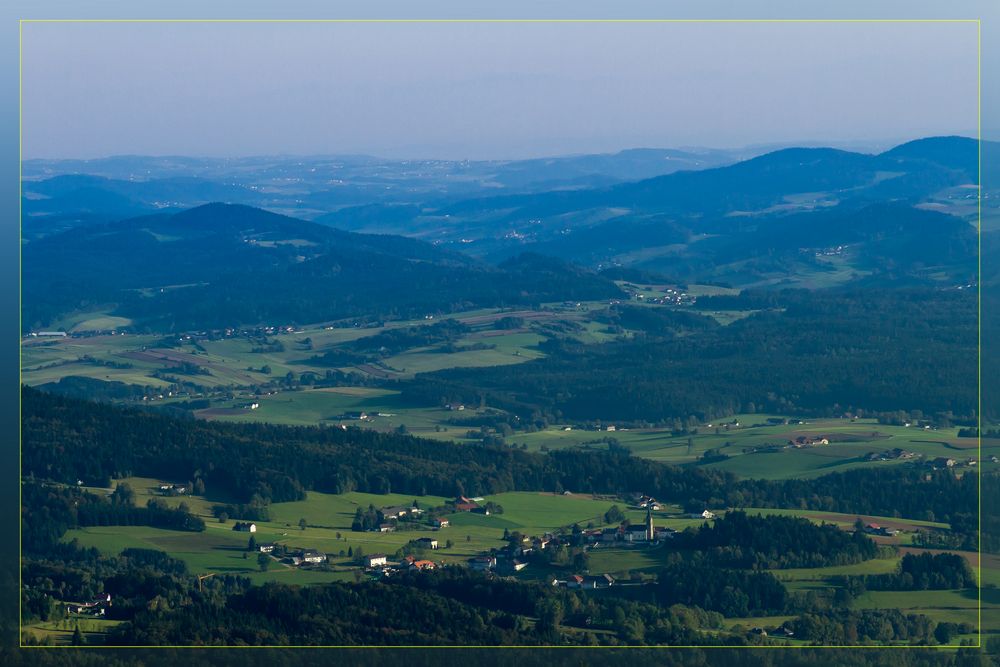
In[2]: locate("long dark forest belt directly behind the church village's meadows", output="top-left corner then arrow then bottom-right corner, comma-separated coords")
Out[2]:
22,387 -> 977,521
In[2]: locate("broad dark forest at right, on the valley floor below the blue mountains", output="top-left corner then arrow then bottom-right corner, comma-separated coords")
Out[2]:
404,289 -> 978,424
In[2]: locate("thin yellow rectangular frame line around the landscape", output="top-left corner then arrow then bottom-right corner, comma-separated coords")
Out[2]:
17,18 -> 983,650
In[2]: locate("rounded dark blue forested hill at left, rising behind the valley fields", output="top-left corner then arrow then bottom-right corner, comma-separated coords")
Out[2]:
23,204 -> 620,331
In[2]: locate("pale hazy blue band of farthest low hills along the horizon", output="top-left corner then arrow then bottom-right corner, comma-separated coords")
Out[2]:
22,148 -> 755,239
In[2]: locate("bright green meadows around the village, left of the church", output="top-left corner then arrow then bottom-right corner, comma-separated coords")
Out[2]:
64,478 -> 684,583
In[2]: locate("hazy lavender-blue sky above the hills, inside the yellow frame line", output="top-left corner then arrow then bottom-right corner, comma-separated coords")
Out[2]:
23,23 -> 977,159
